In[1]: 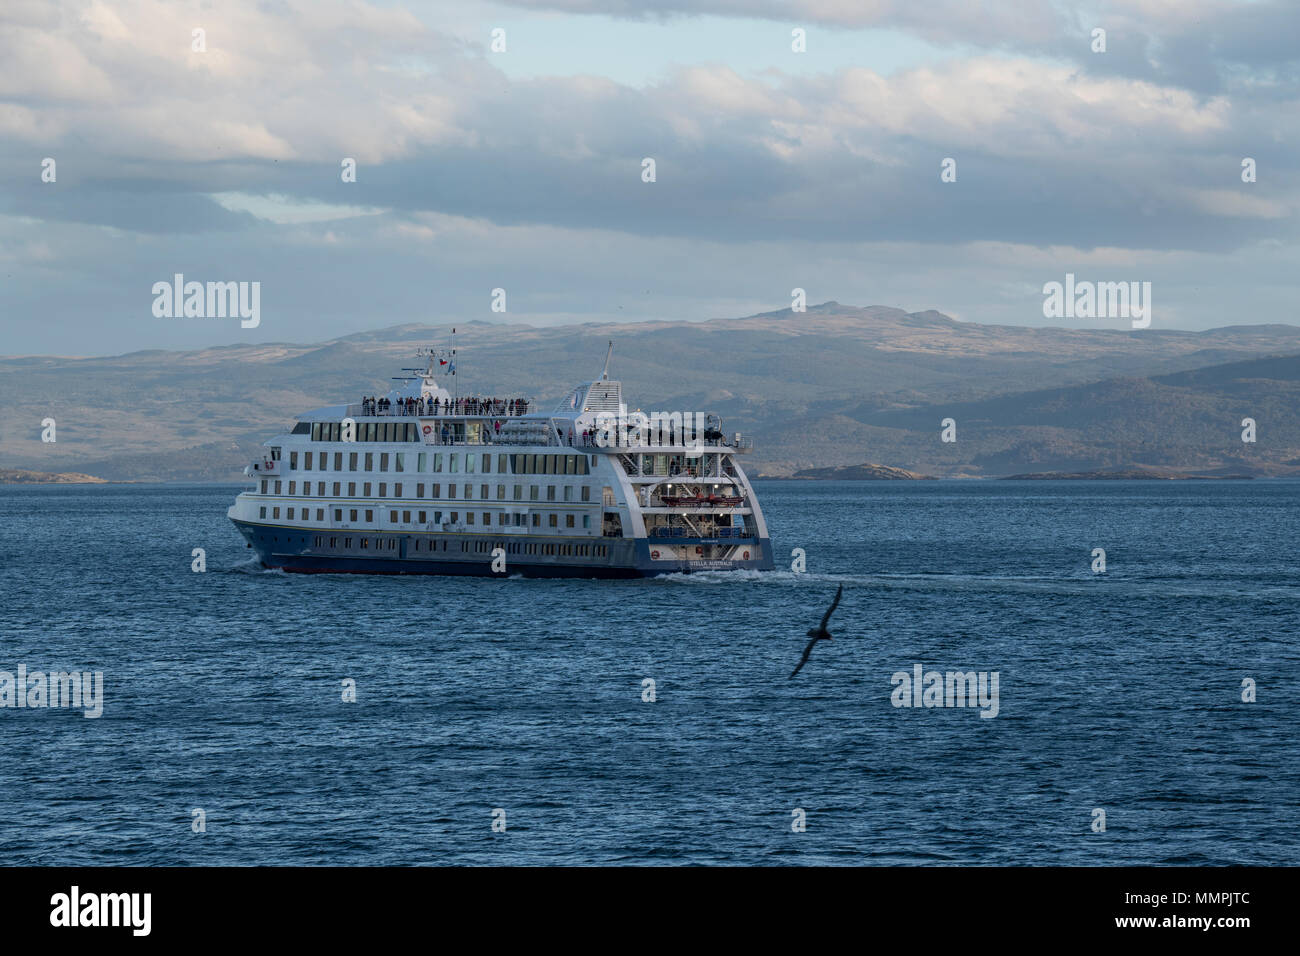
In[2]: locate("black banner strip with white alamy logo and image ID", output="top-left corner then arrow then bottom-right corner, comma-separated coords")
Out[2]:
0,868 -> 1268,948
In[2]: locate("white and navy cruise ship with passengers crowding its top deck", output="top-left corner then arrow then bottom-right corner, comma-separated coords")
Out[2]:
228,343 -> 772,578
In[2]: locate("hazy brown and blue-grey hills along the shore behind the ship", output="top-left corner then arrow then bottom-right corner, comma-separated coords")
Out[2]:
0,302 -> 1300,480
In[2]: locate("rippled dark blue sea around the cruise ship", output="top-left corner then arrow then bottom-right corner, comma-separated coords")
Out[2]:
0,481 -> 1300,865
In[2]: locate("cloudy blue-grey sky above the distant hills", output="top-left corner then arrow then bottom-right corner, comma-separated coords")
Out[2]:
0,0 -> 1300,354
